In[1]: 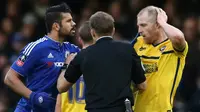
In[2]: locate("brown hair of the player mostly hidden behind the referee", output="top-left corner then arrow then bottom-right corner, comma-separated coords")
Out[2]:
79,21 -> 93,42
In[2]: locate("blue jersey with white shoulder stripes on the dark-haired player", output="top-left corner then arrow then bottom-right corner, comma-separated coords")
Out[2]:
11,36 -> 80,106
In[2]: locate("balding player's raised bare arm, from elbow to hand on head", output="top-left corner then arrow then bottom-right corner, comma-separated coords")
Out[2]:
157,9 -> 186,51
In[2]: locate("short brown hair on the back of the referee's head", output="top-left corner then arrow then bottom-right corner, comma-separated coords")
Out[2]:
89,11 -> 114,36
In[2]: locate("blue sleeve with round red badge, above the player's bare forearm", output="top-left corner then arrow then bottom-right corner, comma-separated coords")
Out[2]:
11,43 -> 40,77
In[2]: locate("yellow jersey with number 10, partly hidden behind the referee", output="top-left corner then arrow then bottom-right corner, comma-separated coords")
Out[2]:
61,76 -> 87,112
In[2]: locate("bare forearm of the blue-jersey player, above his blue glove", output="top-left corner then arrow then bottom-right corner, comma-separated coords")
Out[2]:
4,68 -> 32,99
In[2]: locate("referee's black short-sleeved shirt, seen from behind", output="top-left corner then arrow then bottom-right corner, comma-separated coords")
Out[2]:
64,37 -> 145,110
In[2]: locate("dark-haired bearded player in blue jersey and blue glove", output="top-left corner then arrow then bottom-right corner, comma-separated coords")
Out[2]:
4,3 -> 79,112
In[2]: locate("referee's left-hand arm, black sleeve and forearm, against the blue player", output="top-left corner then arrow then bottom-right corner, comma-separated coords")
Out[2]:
57,55 -> 82,93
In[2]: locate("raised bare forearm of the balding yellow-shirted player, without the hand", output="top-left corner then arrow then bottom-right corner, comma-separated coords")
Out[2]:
160,23 -> 185,50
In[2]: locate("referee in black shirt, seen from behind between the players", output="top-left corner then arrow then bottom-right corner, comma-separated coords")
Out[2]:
57,11 -> 146,112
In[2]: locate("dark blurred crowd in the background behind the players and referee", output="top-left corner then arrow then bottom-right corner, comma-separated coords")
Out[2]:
0,0 -> 200,112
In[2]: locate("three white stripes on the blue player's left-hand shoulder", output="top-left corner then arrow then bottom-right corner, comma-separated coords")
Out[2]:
23,37 -> 47,56
